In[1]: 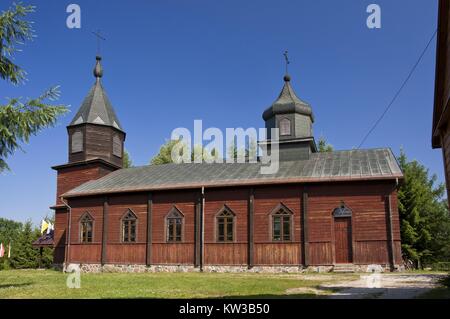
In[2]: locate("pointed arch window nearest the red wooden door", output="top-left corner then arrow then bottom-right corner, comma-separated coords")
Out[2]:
270,203 -> 293,241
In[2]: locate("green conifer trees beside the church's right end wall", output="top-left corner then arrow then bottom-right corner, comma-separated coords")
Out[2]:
398,150 -> 450,268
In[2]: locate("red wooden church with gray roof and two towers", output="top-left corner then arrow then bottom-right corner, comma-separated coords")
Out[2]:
52,57 -> 403,271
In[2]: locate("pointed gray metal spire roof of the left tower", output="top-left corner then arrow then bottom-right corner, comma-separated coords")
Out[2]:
69,57 -> 123,131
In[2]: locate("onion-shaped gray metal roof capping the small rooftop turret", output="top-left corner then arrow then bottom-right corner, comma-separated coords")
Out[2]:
263,75 -> 314,122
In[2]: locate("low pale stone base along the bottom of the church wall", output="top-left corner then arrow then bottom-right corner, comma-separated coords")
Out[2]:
61,263 -> 404,273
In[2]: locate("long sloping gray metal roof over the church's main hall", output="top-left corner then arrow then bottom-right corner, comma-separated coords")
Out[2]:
63,148 -> 403,197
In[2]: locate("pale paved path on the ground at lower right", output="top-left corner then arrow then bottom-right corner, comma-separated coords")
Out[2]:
321,274 -> 445,299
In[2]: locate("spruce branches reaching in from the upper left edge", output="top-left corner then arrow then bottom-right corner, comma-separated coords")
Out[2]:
0,4 -> 67,171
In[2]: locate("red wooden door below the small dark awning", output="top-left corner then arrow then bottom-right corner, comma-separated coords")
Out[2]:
334,217 -> 352,264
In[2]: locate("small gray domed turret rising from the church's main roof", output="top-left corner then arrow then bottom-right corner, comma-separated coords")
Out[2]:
263,74 -> 317,161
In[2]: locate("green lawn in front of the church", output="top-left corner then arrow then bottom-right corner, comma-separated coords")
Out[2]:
0,270 -> 358,298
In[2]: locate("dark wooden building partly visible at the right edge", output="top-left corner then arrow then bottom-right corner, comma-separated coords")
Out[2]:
431,0 -> 450,205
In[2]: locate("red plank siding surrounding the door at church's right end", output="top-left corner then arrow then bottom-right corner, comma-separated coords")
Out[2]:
308,183 -> 401,265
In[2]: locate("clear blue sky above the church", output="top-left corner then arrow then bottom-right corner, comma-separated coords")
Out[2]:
0,0 -> 444,223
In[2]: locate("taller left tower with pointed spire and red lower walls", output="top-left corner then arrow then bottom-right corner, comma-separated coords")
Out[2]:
51,56 -> 126,264
